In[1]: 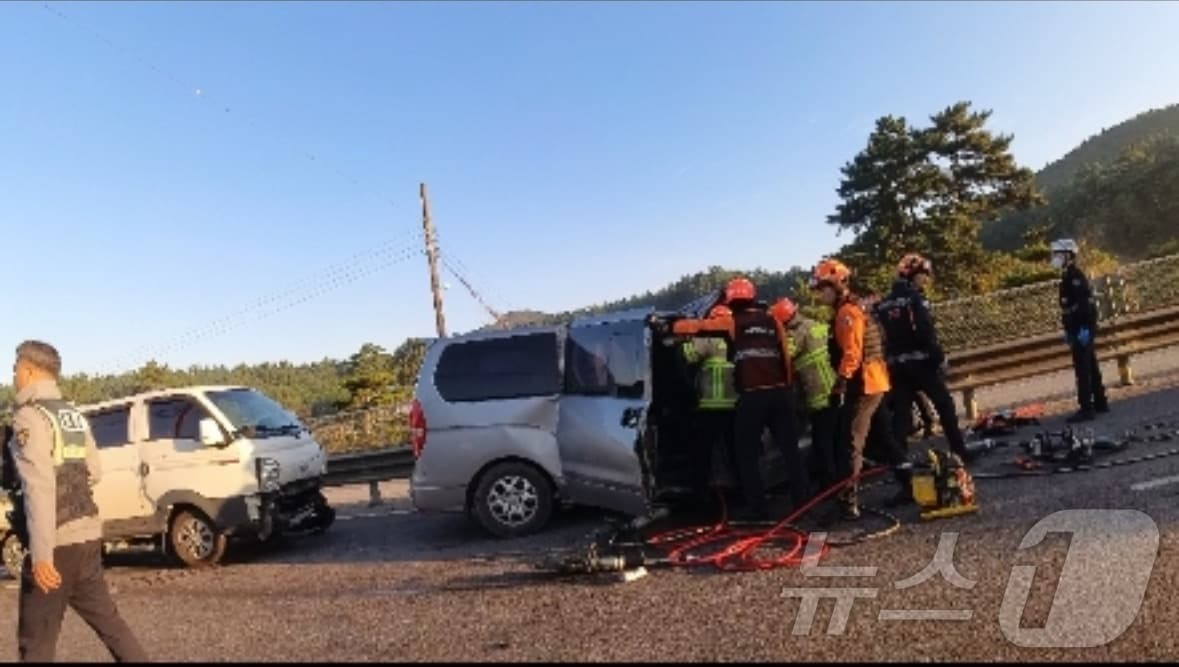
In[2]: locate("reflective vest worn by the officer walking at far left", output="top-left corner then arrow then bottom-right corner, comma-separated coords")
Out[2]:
28,401 -> 98,527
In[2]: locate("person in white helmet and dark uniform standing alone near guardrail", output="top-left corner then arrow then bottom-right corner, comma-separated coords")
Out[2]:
1052,238 -> 1109,424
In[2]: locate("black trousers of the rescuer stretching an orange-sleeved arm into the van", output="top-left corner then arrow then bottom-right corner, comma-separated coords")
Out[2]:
735,388 -> 806,510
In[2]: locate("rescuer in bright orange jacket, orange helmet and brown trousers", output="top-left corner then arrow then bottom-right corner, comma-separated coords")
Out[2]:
811,259 -> 911,520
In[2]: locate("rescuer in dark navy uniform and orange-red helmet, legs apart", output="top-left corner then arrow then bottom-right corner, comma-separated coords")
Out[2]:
876,255 -> 970,461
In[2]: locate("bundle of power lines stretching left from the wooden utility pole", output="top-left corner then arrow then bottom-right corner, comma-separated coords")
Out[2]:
101,245 -> 422,374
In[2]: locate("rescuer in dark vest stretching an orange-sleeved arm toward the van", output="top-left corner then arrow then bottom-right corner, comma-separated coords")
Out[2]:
672,278 -> 808,519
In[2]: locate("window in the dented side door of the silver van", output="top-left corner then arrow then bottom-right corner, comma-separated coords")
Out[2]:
565,323 -> 646,398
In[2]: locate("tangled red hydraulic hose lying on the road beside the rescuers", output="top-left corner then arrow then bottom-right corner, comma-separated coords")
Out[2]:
647,465 -> 889,572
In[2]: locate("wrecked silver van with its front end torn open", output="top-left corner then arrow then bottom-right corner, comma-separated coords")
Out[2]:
410,296 -> 805,536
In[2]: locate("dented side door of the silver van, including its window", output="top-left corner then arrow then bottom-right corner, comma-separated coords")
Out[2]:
556,311 -> 651,515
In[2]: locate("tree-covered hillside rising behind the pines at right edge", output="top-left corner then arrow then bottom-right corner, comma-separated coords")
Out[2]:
981,105 -> 1179,255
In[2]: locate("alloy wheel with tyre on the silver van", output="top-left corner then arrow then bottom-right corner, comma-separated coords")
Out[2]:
472,462 -> 553,537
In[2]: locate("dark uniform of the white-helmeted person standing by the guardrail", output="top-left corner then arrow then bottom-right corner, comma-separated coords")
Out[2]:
1060,263 -> 1109,415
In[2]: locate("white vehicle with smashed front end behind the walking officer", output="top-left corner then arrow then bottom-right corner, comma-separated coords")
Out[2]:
5,387 -> 335,567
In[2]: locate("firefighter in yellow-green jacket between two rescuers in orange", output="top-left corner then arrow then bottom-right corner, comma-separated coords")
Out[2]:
770,297 -> 842,489
